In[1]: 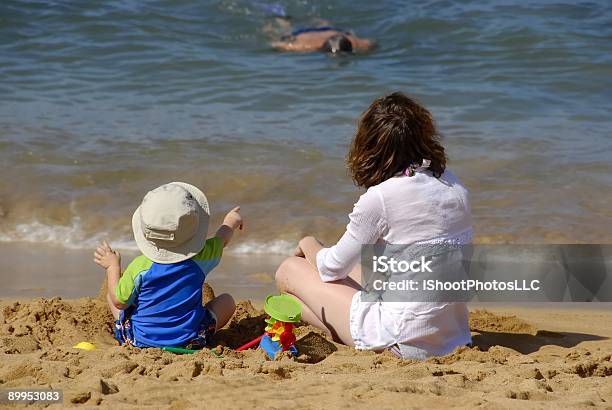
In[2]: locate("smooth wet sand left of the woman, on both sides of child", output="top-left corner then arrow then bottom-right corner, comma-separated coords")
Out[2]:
0,243 -> 284,300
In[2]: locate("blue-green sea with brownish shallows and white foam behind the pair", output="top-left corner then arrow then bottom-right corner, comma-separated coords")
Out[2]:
0,0 -> 612,252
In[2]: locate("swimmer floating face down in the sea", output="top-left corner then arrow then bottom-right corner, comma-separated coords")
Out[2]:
272,20 -> 374,54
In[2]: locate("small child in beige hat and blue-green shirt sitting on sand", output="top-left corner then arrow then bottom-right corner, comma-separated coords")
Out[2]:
94,182 -> 243,349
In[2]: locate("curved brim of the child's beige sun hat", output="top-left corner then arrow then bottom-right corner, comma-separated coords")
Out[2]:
132,182 -> 210,264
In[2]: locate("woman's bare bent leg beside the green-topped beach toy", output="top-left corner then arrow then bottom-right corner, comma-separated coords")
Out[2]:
276,256 -> 360,346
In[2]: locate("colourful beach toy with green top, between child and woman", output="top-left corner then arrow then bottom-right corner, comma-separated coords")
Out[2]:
236,295 -> 302,359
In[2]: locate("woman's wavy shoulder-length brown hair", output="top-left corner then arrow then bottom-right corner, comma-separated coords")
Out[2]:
347,92 -> 446,188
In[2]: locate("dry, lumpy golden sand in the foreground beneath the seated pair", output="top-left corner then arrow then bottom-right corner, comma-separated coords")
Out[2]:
0,286 -> 612,409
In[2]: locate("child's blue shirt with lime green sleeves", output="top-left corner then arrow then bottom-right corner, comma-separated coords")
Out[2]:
115,238 -> 223,347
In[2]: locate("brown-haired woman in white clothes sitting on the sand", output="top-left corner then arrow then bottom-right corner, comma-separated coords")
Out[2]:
276,92 -> 472,359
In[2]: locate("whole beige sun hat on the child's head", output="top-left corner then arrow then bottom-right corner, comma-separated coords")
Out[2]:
132,182 -> 210,263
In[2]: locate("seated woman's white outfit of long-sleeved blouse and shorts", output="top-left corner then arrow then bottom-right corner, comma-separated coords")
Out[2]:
317,170 -> 472,358
